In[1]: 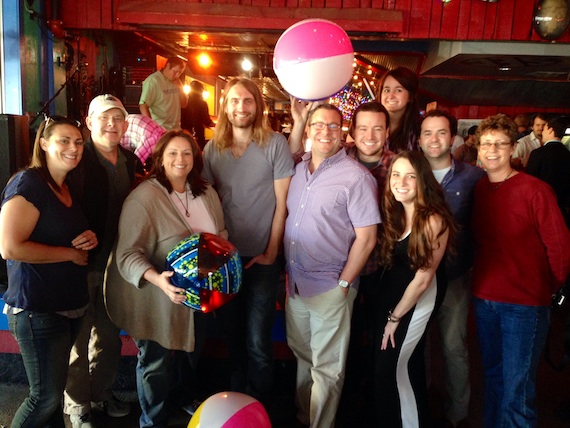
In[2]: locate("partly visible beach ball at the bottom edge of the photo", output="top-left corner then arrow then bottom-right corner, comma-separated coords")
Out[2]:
188,392 -> 271,428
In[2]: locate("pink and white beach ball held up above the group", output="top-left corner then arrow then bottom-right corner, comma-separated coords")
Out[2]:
273,19 -> 354,101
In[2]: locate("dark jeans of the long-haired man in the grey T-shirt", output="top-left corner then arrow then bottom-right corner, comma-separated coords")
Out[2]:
216,257 -> 279,402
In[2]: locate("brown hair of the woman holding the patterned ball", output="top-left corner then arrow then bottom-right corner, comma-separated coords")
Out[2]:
148,131 -> 207,197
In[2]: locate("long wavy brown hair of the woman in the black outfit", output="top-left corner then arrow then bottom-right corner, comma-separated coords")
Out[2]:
380,150 -> 457,270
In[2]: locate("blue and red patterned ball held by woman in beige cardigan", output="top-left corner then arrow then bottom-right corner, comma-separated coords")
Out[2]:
166,232 -> 242,312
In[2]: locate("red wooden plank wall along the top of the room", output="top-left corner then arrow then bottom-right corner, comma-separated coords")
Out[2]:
61,0 -> 570,119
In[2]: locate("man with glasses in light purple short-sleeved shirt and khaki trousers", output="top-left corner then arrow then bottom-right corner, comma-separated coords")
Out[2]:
284,104 -> 380,428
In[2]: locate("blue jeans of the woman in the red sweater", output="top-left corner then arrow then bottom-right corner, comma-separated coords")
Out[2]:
474,298 -> 550,428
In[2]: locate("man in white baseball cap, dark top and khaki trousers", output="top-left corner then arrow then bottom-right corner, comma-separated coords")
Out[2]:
64,94 -> 144,428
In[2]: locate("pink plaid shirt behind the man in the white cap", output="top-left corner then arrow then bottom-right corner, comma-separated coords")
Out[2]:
121,114 -> 166,164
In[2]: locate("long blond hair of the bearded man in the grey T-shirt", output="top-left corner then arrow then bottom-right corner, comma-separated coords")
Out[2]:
213,77 -> 273,151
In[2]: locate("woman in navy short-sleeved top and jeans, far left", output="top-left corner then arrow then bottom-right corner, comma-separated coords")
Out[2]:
0,117 -> 98,428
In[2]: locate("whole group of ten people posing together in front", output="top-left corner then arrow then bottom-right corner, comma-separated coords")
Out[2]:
0,63 -> 570,428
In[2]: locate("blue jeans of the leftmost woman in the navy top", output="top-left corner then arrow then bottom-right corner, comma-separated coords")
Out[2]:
8,311 -> 82,428
